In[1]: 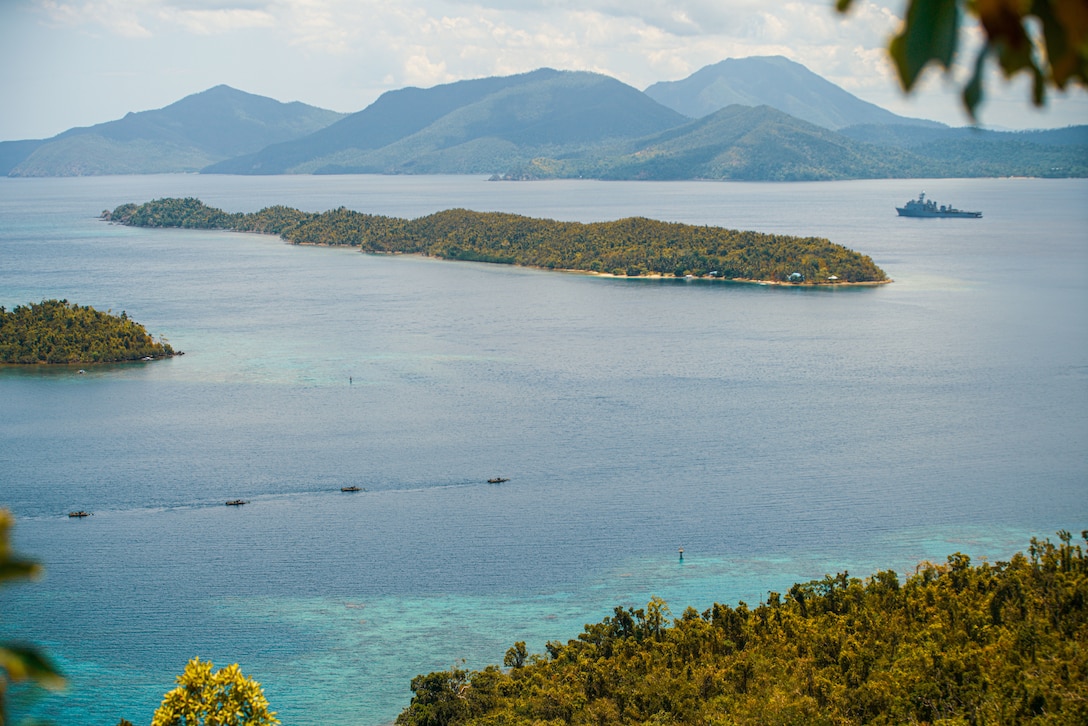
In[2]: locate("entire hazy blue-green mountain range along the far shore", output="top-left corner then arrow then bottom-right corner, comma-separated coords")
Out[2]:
0,57 -> 1088,181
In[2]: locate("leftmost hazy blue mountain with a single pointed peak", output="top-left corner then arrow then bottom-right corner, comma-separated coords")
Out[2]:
0,86 -> 343,176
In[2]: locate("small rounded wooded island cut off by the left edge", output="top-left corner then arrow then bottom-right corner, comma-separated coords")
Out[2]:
0,299 -> 182,365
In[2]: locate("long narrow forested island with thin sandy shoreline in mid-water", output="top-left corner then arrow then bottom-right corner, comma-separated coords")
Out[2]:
102,197 -> 889,285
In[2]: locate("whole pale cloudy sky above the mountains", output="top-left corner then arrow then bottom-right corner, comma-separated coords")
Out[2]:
0,0 -> 1088,140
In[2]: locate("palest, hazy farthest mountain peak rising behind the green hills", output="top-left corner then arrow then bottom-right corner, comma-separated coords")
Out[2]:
646,56 -> 943,130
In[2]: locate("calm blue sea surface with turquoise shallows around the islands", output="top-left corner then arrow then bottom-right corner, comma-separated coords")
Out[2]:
0,175 -> 1088,726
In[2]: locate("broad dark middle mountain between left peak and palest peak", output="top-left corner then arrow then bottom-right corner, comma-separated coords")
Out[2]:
205,69 -> 688,174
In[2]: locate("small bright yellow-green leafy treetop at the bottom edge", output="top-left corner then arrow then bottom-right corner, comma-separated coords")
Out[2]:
146,657 -> 280,726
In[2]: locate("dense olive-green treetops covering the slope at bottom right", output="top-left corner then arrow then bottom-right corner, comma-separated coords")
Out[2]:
397,531 -> 1088,726
